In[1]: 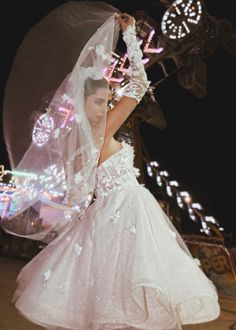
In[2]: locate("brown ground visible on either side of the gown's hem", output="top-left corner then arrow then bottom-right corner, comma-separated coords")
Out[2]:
0,256 -> 236,330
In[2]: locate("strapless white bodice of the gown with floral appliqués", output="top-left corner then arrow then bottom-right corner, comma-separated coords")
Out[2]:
95,141 -> 139,198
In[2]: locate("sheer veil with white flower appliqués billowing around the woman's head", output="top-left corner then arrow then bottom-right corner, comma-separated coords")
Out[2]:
1,1 -> 119,241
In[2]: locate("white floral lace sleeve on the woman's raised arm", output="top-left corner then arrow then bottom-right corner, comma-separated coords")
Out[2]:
123,25 -> 150,103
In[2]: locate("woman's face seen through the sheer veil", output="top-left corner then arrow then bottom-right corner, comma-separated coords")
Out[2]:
85,87 -> 109,124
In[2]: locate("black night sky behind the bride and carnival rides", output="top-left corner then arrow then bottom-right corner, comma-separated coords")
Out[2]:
0,0 -> 236,237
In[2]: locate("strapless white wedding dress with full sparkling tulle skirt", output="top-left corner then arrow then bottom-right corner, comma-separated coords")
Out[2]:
13,141 -> 220,330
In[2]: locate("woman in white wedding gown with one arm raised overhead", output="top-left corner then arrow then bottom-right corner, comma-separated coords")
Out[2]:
1,3 -> 219,330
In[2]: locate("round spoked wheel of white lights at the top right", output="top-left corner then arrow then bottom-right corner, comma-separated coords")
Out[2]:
161,0 -> 202,39
